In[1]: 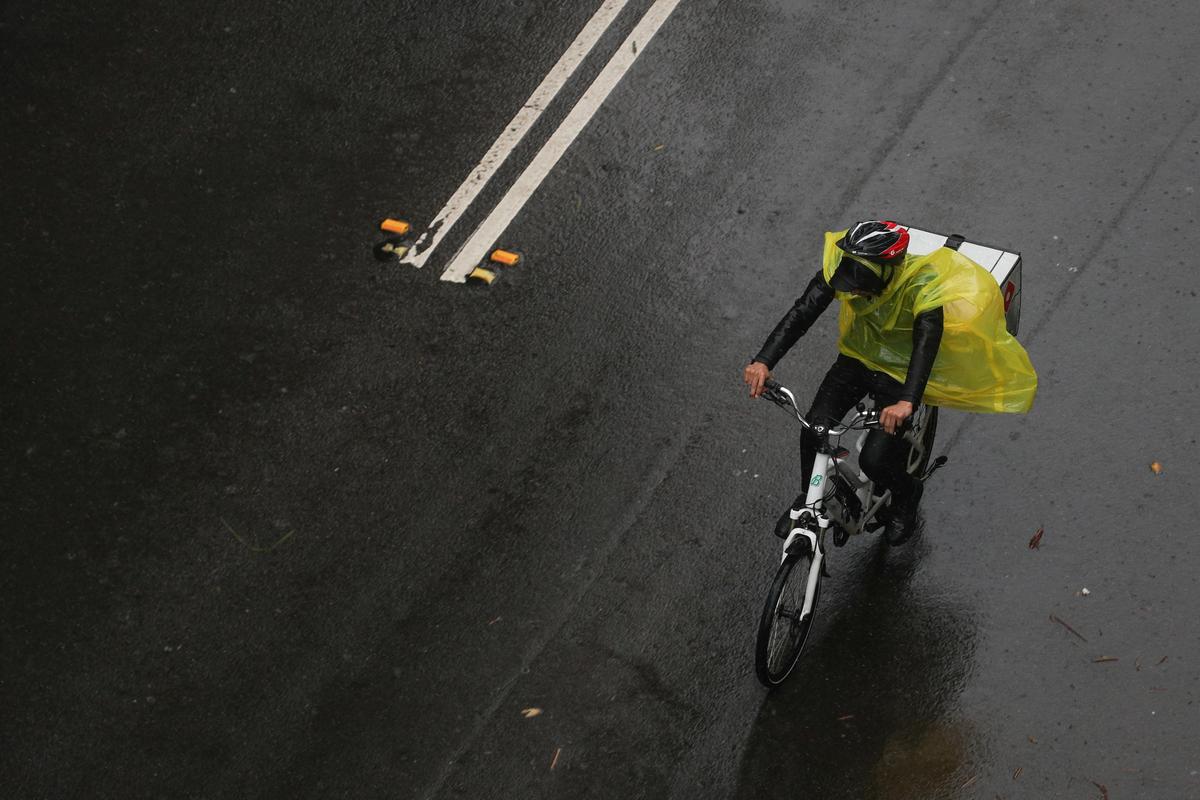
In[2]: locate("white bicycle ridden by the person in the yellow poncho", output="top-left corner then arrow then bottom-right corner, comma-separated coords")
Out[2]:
755,380 -> 947,688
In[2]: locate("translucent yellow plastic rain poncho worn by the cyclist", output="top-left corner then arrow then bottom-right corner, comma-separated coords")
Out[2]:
824,231 -> 1038,413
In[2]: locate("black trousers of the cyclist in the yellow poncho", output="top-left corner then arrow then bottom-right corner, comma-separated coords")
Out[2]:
800,355 -> 917,503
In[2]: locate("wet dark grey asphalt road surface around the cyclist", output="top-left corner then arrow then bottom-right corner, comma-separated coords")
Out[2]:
0,0 -> 1200,800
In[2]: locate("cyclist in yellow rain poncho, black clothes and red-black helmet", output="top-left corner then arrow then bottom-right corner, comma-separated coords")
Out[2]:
743,219 -> 1037,542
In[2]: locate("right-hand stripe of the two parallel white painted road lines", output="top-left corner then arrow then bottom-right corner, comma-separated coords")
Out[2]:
442,0 -> 680,283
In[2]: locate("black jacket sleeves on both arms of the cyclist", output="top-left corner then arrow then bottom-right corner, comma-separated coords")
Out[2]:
754,270 -> 943,405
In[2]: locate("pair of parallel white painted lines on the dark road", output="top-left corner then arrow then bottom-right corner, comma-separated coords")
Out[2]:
402,0 -> 682,283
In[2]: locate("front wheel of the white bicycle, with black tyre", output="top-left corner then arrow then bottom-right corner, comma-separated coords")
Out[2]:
755,552 -> 821,688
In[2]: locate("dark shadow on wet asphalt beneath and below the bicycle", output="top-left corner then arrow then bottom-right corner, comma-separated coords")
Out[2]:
736,537 -> 978,800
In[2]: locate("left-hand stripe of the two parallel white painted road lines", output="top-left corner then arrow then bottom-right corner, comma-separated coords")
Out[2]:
400,0 -> 629,267
